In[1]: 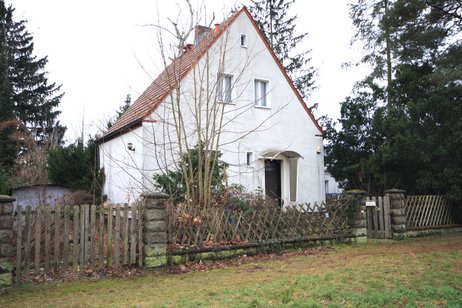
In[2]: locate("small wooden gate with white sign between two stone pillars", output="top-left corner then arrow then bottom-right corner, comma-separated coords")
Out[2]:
366,195 -> 392,238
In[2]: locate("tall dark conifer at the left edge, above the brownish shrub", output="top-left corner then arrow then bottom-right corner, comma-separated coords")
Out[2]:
0,0 -> 65,150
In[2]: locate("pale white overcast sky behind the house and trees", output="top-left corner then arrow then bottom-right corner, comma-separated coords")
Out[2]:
10,0 -> 365,142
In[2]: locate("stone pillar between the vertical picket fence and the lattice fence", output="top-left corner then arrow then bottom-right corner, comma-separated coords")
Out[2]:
142,192 -> 169,269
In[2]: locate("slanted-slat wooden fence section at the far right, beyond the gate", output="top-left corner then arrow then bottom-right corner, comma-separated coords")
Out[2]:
405,195 -> 460,230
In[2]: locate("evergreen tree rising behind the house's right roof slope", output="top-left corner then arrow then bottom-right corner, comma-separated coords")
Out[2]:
249,0 -> 316,98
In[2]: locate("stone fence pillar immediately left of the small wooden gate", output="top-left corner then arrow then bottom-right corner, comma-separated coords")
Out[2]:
345,189 -> 367,242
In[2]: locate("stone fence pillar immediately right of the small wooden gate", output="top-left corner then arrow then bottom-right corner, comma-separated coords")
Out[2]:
385,189 -> 406,240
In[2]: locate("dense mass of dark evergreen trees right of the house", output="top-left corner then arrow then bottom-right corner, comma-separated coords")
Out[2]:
326,0 -> 462,201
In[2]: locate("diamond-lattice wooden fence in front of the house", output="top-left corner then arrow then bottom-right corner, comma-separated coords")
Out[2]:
167,196 -> 351,249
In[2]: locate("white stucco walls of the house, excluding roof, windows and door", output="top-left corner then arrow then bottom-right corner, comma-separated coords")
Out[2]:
100,13 -> 325,204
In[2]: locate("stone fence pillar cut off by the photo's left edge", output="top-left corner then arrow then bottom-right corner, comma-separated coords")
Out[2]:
0,195 -> 16,289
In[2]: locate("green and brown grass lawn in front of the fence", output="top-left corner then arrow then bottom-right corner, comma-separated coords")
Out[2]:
0,233 -> 462,307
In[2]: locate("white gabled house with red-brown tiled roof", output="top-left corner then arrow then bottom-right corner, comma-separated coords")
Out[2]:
99,7 -> 325,205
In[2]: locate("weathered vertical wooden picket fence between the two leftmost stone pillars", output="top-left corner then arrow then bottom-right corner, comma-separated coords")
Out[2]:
14,204 -> 142,282
